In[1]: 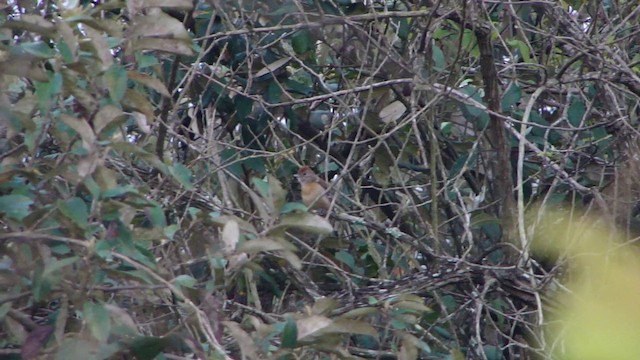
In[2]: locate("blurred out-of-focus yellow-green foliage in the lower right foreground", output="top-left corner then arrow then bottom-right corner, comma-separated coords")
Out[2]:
534,212 -> 640,360
